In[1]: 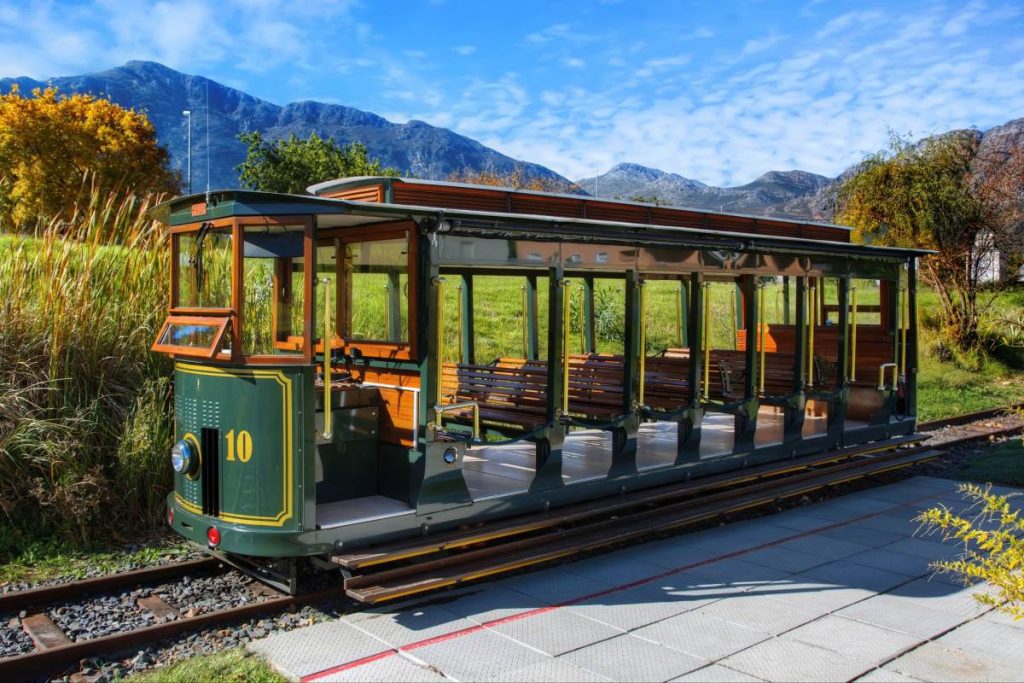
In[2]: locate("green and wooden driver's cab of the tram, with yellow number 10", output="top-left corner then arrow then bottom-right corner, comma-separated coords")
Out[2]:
153,191 -> 420,548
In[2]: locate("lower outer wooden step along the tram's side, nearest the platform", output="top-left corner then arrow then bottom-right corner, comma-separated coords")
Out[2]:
345,450 -> 942,604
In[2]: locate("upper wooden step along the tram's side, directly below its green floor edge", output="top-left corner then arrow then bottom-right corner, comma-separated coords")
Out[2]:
332,434 -> 925,570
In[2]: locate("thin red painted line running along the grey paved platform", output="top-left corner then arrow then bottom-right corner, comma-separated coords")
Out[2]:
299,494 -> 934,683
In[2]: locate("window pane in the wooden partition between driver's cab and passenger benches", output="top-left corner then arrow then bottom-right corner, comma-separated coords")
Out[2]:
344,238 -> 409,343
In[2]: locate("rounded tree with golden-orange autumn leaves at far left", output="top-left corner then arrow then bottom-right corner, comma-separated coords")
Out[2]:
0,86 -> 180,230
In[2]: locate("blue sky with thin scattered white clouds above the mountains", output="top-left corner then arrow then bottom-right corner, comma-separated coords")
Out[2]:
0,0 -> 1024,185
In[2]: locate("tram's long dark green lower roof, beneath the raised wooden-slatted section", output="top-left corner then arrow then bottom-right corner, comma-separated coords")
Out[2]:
151,189 -> 934,258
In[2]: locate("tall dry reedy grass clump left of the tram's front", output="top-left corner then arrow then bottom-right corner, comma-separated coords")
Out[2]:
0,185 -> 173,561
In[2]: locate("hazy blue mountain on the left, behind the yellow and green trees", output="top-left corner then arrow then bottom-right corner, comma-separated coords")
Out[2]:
0,61 -> 568,190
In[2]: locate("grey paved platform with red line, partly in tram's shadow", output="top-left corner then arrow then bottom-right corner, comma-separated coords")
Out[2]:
251,477 -> 1024,681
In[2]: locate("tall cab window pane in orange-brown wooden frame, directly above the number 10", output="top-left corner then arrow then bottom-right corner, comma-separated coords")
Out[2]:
242,225 -> 305,355
